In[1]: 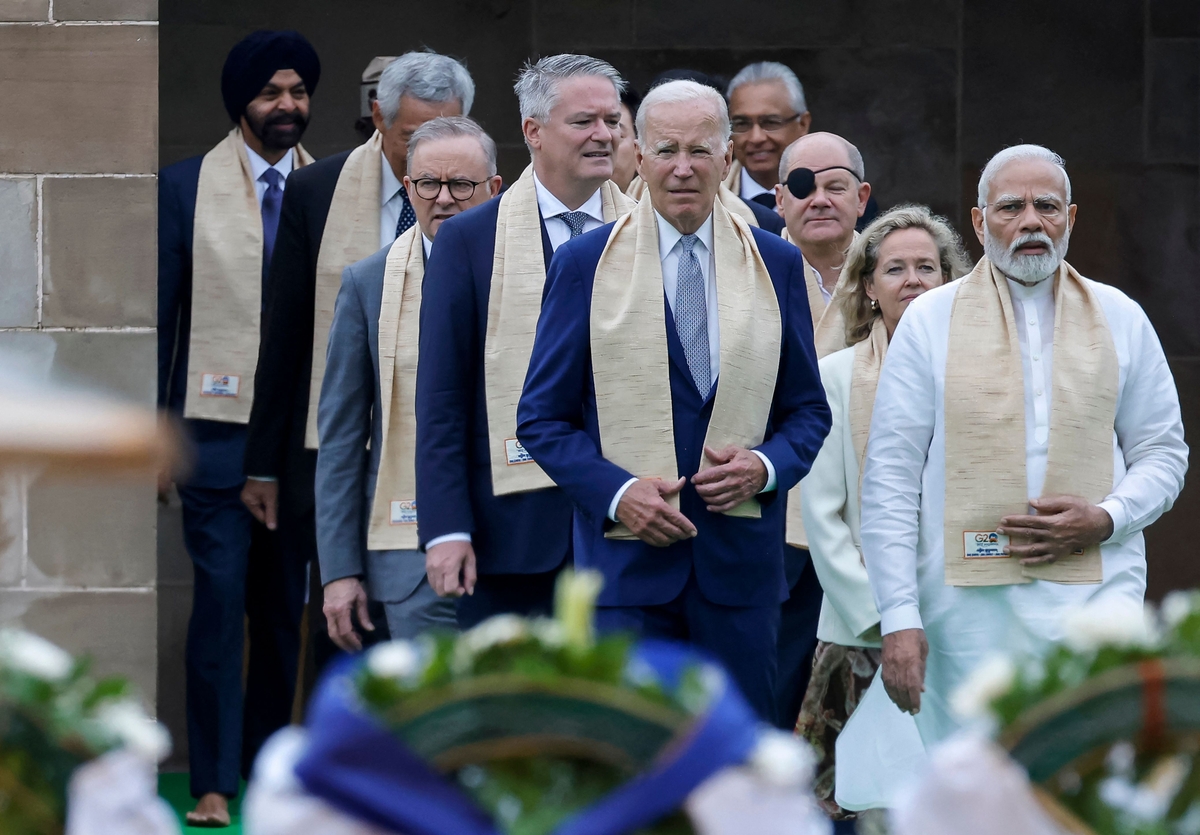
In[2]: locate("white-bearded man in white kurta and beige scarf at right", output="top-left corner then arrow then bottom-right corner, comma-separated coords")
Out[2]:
862,145 -> 1188,745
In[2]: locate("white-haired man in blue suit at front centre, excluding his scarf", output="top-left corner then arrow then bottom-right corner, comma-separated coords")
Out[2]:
517,80 -> 830,719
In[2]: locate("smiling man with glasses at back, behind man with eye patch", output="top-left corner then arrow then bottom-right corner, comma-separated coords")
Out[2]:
725,61 -> 812,211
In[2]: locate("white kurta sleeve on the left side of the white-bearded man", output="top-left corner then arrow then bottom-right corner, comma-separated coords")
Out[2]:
862,309 -> 937,635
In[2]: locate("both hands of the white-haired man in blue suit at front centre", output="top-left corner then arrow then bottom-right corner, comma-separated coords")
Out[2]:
617,446 -> 767,548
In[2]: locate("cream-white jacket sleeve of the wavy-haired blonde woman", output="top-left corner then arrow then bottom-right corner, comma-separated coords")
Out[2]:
800,358 -> 880,637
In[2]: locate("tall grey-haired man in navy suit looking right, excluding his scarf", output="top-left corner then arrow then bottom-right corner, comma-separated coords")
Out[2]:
416,55 -> 624,627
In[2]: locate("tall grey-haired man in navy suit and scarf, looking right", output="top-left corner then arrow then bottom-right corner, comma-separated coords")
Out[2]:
416,55 -> 625,626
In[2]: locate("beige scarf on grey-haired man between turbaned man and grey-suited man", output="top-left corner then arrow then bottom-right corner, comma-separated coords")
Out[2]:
305,131 -> 383,450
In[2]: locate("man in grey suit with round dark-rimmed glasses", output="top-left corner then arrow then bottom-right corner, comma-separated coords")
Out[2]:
317,116 -> 500,651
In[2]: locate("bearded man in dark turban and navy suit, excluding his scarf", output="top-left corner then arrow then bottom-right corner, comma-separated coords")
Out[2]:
158,31 -> 320,825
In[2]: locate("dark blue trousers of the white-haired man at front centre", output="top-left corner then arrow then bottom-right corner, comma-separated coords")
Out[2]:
596,573 -> 779,720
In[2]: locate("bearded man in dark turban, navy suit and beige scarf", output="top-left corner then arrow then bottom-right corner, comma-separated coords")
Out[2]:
158,31 -> 320,827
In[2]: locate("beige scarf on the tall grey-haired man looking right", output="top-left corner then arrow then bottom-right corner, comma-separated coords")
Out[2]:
484,164 -> 634,495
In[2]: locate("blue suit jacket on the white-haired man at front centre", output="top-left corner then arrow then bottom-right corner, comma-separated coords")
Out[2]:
517,218 -> 830,606
